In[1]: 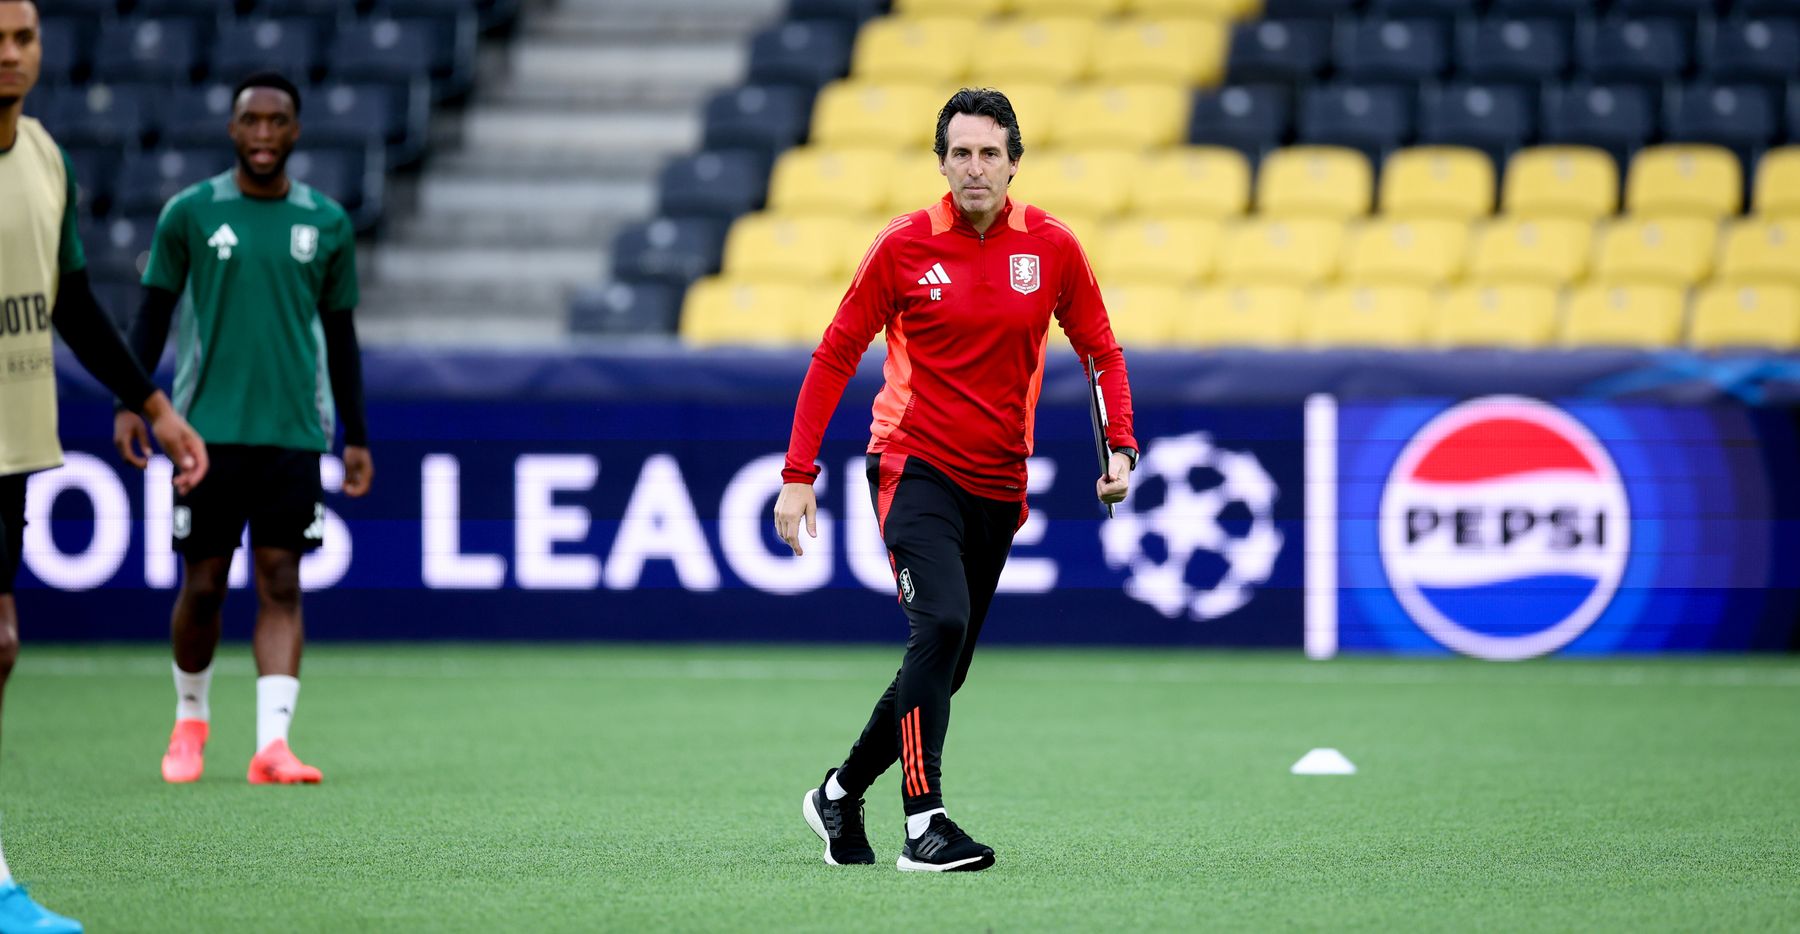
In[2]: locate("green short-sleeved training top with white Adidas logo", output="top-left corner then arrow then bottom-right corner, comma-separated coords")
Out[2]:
144,171 -> 356,452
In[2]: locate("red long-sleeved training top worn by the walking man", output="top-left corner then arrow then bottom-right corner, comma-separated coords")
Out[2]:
781,194 -> 1138,500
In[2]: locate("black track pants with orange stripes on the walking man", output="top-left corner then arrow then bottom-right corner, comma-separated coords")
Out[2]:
837,454 -> 1024,813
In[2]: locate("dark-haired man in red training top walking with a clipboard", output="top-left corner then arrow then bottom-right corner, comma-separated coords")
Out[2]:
776,88 -> 1138,873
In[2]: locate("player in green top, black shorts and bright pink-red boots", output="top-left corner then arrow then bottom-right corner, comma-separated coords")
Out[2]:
113,72 -> 374,785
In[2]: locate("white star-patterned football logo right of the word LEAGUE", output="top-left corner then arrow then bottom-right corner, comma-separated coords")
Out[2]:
1100,432 -> 1282,621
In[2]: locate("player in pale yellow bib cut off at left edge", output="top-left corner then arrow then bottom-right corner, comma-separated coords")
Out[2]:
0,0 -> 207,934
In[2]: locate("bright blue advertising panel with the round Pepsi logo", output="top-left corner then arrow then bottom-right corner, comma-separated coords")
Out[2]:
1336,396 -> 1800,659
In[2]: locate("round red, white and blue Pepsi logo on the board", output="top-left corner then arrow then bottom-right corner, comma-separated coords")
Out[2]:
1379,396 -> 1631,660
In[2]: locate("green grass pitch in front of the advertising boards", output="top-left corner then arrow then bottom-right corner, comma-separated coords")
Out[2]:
0,641 -> 1800,934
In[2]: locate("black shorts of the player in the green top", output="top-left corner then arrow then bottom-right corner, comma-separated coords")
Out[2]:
173,445 -> 326,558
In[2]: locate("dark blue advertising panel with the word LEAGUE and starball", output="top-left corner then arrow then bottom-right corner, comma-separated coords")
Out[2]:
20,390 -> 1303,646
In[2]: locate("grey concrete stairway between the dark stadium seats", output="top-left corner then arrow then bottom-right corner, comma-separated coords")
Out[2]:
358,0 -> 785,346
